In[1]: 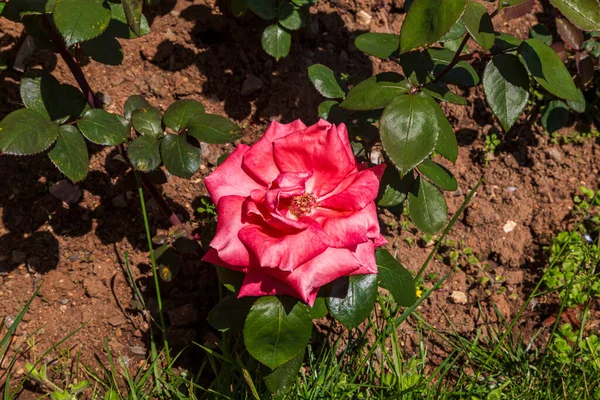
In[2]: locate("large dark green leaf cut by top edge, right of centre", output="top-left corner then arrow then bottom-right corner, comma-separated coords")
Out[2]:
400,0 -> 466,53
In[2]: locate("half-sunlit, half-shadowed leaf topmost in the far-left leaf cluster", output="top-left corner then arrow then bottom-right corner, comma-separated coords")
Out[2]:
21,69 -> 88,121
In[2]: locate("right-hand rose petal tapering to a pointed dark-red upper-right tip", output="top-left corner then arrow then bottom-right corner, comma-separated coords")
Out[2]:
319,164 -> 385,211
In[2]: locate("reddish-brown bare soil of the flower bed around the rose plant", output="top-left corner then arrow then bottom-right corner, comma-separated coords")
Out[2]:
0,0 -> 600,398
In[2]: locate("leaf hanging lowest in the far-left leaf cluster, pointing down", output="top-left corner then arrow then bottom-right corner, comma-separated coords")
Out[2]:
48,125 -> 90,182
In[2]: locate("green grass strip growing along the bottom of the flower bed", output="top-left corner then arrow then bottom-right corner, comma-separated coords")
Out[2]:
0,184 -> 600,400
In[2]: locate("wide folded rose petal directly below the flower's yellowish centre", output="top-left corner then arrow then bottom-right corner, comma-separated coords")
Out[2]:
238,220 -> 329,271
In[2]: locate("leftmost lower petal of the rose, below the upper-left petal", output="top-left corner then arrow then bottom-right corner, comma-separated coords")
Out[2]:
202,196 -> 250,267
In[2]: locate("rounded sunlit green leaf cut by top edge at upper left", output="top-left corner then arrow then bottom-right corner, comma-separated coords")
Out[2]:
52,0 -> 110,47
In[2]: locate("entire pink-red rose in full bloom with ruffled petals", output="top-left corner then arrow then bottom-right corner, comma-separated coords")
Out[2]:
203,120 -> 386,306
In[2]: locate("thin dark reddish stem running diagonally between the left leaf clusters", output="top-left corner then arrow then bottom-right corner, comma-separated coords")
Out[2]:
41,15 -> 203,255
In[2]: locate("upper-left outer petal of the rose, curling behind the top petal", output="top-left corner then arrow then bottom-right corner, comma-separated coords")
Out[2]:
242,119 -> 306,186
